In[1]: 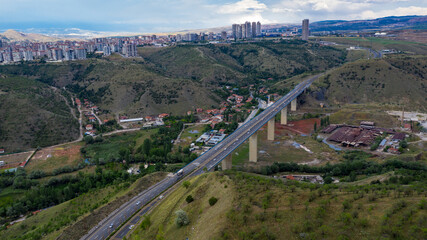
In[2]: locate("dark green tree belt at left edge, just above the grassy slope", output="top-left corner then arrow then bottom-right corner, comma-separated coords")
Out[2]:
0,167 -> 136,218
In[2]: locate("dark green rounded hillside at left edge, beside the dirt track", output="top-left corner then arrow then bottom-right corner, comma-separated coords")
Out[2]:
0,76 -> 79,152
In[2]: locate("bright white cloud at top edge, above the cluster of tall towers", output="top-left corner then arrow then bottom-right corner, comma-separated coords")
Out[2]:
217,0 -> 267,14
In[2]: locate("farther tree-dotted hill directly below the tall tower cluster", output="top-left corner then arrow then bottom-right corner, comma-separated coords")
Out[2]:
140,41 -> 346,84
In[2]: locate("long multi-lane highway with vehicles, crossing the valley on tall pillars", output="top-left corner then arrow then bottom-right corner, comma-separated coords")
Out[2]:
81,74 -> 321,240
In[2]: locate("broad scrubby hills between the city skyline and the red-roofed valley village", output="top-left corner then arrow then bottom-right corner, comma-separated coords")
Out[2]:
0,41 -> 346,116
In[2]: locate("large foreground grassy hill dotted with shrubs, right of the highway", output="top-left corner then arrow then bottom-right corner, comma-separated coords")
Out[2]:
131,173 -> 427,239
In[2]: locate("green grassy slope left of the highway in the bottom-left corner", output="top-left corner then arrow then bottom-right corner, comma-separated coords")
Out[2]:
0,173 -> 165,239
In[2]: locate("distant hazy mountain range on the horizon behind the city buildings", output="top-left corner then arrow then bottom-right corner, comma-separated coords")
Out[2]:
0,16 -> 427,42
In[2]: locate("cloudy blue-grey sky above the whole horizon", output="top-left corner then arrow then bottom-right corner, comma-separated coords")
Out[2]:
0,0 -> 427,33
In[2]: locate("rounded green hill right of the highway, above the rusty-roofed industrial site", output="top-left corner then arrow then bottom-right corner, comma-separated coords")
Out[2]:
304,57 -> 427,112
